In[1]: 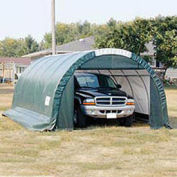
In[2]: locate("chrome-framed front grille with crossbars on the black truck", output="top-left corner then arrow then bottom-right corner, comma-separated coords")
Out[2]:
95,96 -> 127,106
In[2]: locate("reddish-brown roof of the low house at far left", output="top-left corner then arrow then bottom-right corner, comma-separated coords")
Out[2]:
0,57 -> 31,66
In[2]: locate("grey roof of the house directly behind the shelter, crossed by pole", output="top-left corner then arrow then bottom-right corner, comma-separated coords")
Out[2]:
23,36 -> 95,59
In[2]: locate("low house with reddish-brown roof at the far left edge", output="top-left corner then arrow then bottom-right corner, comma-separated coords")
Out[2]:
0,57 -> 31,83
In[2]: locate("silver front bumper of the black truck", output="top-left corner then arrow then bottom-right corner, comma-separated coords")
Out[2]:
81,105 -> 135,118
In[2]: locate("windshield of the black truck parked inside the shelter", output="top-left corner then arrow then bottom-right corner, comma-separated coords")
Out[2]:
76,74 -> 117,88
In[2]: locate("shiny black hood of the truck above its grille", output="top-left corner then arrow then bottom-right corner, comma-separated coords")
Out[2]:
76,88 -> 128,97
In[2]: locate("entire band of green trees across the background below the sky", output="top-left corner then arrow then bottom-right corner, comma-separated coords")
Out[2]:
0,16 -> 177,71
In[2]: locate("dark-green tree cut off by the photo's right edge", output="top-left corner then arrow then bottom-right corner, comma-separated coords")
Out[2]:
153,16 -> 177,75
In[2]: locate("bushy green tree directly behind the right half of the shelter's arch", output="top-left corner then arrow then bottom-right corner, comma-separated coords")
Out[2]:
96,18 -> 152,55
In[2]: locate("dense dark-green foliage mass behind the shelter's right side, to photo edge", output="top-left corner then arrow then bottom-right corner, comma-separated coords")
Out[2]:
96,16 -> 177,69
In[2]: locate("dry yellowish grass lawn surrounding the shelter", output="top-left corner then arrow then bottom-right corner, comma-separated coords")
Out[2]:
0,86 -> 177,177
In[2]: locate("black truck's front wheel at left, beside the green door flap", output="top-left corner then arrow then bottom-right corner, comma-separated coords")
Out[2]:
74,107 -> 87,128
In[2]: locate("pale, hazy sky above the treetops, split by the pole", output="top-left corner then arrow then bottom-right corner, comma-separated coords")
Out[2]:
0,0 -> 177,41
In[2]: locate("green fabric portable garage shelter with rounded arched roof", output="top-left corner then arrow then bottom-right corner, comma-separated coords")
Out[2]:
4,49 -> 168,131
